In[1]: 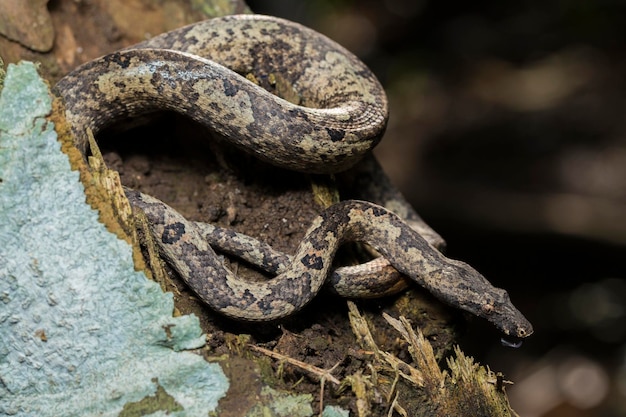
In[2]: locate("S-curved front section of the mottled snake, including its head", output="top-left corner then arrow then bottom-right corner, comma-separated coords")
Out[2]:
126,190 -> 533,337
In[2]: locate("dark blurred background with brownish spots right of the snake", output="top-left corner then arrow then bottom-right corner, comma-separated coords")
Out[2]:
247,0 -> 626,417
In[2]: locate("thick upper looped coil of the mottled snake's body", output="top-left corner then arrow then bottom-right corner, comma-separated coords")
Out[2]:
56,15 -> 388,174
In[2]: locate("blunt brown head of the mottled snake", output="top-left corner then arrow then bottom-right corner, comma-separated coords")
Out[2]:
479,287 -> 533,339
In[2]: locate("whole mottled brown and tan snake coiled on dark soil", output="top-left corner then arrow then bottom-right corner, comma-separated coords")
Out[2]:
53,15 -> 533,338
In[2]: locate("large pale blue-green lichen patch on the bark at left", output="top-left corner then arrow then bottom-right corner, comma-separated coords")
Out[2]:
0,63 -> 228,416
